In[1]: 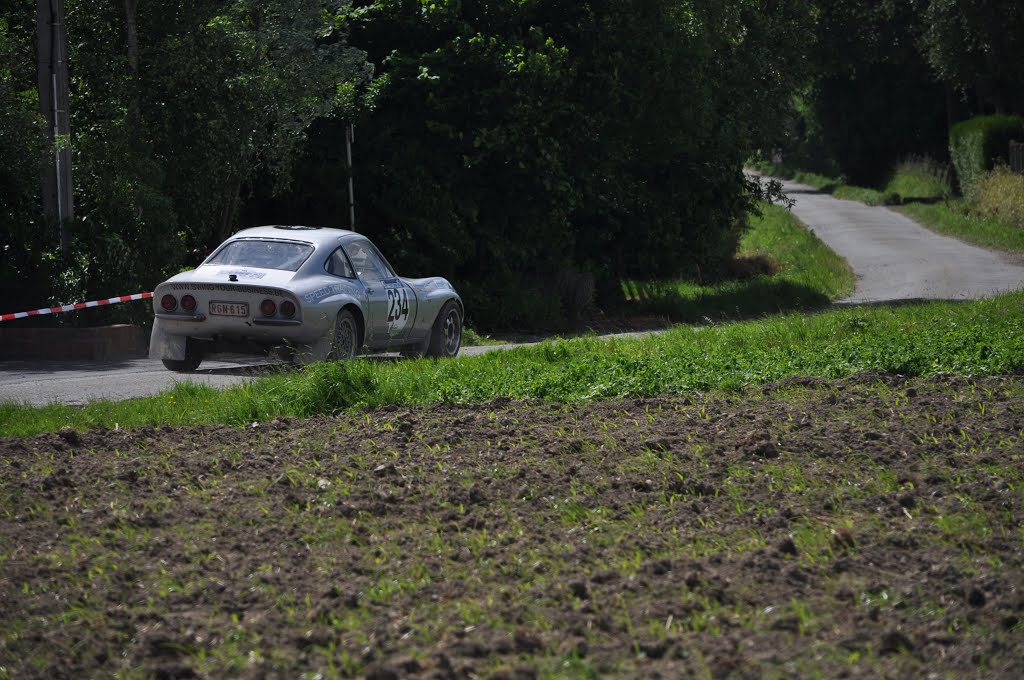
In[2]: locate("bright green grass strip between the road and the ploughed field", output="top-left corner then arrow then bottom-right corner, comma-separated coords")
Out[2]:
0,292 -> 1024,435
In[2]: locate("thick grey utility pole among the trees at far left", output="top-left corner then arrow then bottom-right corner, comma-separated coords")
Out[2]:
36,0 -> 75,253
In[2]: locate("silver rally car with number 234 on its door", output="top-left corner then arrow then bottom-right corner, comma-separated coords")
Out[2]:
150,226 -> 464,371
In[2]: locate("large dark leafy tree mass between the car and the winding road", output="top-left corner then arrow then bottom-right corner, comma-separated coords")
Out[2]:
256,0 -> 810,328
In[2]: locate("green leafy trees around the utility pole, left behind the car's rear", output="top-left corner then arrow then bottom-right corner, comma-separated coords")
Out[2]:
0,0 -> 369,323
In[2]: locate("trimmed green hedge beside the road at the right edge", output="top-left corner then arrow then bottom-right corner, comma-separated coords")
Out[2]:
949,116 -> 1024,203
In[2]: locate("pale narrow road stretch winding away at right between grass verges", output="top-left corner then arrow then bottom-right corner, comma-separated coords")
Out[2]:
782,181 -> 1024,303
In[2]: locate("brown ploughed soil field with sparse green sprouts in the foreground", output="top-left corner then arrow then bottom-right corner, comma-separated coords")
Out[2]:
0,376 -> 1024,678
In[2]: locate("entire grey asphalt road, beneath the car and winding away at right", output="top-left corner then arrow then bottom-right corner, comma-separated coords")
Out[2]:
0,182 -> 1024,406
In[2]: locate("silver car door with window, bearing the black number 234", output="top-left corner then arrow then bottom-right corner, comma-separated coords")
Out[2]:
344,239 -> 416,349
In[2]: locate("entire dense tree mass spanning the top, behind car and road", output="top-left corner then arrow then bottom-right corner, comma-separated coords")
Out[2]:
0,0 -> 1024,325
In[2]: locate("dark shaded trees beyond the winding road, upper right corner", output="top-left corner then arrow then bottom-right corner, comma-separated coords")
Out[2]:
778,0 -> 1024,185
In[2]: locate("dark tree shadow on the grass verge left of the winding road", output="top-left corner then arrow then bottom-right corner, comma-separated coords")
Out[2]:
615,279 -> 831,323
